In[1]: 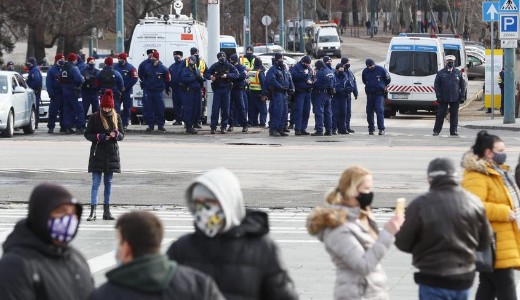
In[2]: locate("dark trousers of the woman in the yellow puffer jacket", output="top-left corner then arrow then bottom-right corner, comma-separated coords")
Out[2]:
475,269 -> 516,300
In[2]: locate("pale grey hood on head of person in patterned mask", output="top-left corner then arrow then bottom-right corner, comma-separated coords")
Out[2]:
185,168 -> 246,232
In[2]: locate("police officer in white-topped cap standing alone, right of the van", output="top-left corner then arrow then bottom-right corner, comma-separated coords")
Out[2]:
433,55 -> 466,136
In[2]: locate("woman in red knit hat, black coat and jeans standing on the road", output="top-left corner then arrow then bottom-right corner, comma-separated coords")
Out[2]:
85,89 -> 125,221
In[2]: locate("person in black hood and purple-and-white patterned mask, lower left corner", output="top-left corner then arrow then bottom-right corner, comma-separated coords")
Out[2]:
0,183 -> 94,300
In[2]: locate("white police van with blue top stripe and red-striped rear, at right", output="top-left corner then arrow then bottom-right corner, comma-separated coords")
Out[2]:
385,35 -> 445,118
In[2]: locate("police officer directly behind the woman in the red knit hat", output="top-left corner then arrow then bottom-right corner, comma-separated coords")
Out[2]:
96,56 -> 124,114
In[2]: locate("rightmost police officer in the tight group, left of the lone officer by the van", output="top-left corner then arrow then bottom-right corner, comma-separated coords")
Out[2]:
332,63 -> 357,134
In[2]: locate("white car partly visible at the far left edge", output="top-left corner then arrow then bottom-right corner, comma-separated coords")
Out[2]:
0,71 -> 36,137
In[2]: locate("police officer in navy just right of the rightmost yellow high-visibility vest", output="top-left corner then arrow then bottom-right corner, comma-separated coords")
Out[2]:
266,52 -> 293,137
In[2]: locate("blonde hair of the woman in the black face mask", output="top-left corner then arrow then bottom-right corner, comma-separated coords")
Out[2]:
326,166 -> 372,205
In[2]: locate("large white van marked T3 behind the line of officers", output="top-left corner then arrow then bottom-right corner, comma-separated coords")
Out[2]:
128,0 -> 208,124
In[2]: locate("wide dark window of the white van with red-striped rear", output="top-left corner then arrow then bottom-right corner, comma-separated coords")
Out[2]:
389,51 -> 437,76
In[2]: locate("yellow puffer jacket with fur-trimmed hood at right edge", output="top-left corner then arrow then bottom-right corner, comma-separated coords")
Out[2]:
462,151 -> 520,269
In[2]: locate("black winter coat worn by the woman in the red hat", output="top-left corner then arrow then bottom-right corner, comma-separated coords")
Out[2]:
85,111 -> 125,173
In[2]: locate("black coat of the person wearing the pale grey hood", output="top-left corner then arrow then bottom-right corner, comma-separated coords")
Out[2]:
167,211 -> 298,300
